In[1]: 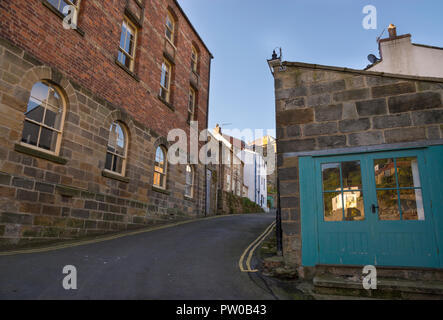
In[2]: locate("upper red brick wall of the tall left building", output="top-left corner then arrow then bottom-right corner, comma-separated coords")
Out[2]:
0,0 -> 211,136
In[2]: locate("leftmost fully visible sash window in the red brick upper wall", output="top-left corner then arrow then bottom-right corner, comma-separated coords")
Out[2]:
118,18 -> 137,71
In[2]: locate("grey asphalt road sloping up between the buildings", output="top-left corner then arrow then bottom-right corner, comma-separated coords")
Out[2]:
0,214 -> 274,300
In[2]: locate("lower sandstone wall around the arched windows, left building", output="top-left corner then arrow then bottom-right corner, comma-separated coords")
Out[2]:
0,40 -> 205,246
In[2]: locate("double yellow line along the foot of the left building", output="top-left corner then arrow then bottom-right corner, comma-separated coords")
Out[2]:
0,214 -> 250,257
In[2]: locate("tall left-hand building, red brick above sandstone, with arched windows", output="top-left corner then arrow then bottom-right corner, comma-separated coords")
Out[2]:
0,0 -> 212,245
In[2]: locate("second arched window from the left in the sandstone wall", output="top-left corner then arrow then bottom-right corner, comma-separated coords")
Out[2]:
105,122 -> 128,176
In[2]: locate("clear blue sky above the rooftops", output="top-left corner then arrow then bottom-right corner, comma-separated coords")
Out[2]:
178,0 -> 443,140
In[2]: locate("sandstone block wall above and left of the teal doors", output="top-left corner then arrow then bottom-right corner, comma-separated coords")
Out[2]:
274,63 -> 443,266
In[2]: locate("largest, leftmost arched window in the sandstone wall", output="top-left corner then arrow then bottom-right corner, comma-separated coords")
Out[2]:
21,81 -> 66,154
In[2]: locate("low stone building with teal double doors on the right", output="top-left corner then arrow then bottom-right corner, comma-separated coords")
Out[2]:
269,53 -> 443,286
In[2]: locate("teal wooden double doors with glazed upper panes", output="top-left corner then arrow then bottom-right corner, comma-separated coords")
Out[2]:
313,150 -> 439,267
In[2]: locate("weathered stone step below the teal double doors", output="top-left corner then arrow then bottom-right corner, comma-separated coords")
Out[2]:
313,274 -> 443,300
